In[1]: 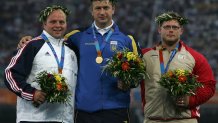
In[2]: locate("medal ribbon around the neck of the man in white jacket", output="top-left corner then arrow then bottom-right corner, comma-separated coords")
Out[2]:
41,33 -> 65,74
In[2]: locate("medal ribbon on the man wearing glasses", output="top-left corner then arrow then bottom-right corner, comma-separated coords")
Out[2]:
159,43 -> 179,74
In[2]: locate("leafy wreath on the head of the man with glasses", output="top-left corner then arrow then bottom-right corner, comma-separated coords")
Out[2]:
155,12 -> 188,25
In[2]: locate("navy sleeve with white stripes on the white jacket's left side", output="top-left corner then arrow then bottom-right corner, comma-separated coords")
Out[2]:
4,43 -> 35,100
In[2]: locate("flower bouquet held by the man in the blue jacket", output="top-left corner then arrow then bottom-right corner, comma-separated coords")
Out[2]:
103,49 -> 145,91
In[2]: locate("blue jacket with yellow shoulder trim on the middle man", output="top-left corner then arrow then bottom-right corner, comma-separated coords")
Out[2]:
65,19 -> 137,121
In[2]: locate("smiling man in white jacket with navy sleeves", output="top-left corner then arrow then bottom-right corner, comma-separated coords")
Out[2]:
5,6 -> 78,123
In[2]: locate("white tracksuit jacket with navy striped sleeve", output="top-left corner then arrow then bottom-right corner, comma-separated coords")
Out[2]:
5,31 -> 78,123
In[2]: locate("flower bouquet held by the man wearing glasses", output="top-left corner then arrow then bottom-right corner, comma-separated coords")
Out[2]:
158,69 -> 202,97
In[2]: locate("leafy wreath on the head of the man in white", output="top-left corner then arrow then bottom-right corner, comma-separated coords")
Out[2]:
39,5 -> 71,22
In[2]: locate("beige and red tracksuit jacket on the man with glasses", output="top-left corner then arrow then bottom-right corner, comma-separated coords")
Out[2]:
141,41 -> 216,123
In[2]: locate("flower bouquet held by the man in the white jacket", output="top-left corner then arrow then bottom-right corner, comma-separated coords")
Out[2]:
35,71 -> 71,106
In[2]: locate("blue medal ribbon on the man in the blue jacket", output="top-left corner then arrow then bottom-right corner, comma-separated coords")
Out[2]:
92,24 -> 114,57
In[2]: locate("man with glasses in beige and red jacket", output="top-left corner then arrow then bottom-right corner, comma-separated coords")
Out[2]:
141,12 -> 216,123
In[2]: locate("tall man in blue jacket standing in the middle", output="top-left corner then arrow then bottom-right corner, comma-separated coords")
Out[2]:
68,0 -> 140,123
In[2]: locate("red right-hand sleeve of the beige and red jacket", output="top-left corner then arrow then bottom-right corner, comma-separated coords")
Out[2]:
189,55 -> 216,108
